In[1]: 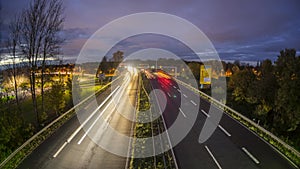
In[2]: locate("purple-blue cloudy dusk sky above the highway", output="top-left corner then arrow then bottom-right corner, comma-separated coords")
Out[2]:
1,0 -> 300,61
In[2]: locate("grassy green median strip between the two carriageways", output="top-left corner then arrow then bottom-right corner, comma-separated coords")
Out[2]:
129,75 -> 175,169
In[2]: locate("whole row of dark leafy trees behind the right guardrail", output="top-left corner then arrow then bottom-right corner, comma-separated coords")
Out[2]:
227,49 -> 300,150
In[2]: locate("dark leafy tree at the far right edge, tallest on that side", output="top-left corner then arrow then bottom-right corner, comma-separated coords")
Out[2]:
274,49 -> 300,132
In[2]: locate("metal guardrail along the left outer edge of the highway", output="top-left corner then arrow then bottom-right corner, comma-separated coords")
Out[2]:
0,76 -> 120,168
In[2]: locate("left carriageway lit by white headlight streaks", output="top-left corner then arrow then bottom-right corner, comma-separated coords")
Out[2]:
18,74 -> 138,169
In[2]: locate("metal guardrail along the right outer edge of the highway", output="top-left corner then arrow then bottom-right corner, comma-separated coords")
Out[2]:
173,78 -> 300,164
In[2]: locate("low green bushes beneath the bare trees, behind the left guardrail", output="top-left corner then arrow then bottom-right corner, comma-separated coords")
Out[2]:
0,75 -> 81,161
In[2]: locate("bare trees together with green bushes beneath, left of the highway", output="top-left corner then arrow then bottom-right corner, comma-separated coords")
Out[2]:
0,0 -> 67,161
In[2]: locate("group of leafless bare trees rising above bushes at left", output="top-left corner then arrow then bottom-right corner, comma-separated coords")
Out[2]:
2,0 -> 64,128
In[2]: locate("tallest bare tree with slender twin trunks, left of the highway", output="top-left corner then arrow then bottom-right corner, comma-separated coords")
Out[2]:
21,0 -> 63,124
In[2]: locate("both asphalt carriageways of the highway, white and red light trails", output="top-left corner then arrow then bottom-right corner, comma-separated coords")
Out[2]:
18,70 -> 296,169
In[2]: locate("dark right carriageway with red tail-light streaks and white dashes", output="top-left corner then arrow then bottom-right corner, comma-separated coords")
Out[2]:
149,72 -> 296,169
